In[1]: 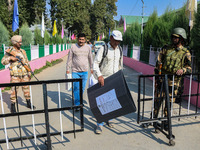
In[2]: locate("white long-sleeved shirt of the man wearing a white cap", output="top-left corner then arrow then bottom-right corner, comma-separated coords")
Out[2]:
93,44 -> 123,78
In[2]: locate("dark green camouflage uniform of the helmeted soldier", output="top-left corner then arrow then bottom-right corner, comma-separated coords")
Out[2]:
154,45 -> 192,117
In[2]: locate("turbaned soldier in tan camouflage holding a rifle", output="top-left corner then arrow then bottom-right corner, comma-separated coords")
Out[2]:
1,35 -> 35,113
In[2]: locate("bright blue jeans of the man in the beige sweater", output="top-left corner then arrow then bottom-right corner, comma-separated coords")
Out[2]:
72,72 -> 88,106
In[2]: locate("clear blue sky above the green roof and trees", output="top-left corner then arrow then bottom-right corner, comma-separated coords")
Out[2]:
114,0 -> 199,20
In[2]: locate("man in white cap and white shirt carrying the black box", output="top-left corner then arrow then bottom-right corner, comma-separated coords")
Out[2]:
93,30 -> 123,134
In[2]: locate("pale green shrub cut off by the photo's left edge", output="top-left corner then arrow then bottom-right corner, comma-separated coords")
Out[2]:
0,21 -> 9,46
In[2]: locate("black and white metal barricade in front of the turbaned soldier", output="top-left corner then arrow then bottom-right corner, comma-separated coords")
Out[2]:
0,79 -> 84,150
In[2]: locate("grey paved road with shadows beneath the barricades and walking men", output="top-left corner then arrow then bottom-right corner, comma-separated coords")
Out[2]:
0,57 -> 200,150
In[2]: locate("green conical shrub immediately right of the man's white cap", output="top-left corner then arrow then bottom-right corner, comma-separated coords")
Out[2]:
123,22 -> 141,47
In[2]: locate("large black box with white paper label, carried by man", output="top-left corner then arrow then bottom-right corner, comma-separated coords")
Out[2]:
87,70 -> 136,123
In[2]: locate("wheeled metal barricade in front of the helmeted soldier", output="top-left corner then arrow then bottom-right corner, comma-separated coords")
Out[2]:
137,74 -> 200,146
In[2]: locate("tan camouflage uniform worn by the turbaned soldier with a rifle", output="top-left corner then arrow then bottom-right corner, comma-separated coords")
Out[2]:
1,48 -> 31,103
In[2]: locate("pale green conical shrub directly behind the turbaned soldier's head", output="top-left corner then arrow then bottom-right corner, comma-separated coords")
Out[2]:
19,23 -> 34,46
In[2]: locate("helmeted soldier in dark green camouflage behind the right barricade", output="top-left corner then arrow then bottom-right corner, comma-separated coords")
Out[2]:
154,28 -> 192,128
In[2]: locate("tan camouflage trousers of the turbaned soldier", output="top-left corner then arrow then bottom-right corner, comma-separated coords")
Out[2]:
10,75 -> 30,103
